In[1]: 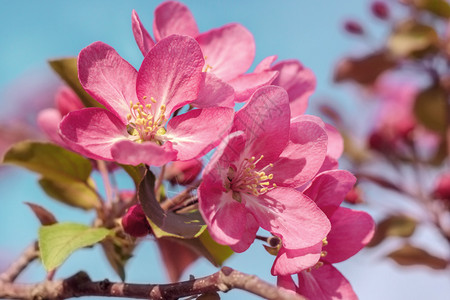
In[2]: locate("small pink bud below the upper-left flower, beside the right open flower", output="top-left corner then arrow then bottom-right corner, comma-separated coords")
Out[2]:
164,159 -> 203,185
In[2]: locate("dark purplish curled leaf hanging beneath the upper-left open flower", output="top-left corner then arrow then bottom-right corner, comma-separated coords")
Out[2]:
138,171 -> 206,239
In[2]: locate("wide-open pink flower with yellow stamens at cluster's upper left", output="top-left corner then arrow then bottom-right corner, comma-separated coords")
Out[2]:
60,35 -> 234,166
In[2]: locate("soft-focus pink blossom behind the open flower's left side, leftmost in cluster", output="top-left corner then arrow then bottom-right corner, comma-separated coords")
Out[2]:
37,86 -> 84,148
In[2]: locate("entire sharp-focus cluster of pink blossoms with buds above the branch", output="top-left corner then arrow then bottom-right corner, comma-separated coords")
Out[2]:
39,1 -> 374,299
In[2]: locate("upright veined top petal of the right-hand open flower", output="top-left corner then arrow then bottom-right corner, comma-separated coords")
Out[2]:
233,86 -> 290,165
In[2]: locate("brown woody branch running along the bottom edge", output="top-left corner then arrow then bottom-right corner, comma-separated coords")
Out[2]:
0,267 -> 305,300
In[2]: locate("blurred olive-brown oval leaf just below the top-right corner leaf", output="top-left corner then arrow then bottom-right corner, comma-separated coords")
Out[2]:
387,20 -> 439,58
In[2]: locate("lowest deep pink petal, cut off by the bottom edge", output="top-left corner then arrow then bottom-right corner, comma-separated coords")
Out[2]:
297,264 -> 358,300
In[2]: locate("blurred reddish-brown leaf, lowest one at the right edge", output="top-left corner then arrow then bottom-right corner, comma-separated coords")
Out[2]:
388,244 -> 448,270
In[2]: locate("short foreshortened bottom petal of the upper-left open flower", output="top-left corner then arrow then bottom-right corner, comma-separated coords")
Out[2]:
111,140 -> 177,167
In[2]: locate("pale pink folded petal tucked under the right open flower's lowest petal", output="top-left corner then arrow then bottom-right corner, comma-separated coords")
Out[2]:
271,241 -> 322,275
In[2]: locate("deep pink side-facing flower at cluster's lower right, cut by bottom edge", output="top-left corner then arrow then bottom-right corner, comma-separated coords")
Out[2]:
272,170 -> 374,299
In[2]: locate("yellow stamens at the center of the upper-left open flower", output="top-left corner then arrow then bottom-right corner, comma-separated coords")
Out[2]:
127,97 -> 167,144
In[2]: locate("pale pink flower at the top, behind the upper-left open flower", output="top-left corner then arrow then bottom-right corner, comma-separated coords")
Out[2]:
132,1 -> 277,103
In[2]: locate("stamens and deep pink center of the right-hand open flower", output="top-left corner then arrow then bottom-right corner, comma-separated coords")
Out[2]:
225,155 -> 277,202
